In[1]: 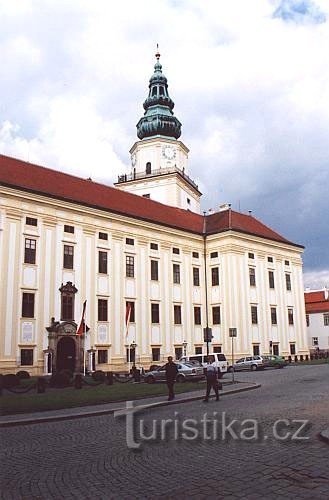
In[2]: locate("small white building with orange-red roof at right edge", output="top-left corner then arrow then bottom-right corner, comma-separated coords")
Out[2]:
305,288 -> 329,353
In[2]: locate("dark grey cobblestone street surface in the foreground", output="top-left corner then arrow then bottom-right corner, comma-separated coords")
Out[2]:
0,365 -> 329,500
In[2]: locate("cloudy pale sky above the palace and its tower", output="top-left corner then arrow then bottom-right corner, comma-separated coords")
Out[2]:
0,0 -> 329,288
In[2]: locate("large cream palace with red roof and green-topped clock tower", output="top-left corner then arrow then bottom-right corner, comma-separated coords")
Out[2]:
0,53 -> 309,374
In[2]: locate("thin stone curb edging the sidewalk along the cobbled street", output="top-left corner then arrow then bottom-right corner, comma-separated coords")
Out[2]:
0,383 -> 261,429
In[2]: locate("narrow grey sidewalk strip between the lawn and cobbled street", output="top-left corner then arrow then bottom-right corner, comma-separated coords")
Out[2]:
0,382 -> 261,428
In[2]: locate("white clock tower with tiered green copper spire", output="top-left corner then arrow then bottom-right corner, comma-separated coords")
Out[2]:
115,50 -> 201,213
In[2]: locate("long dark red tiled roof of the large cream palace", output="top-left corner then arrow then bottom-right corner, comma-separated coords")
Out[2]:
0,155 -> 303,248
